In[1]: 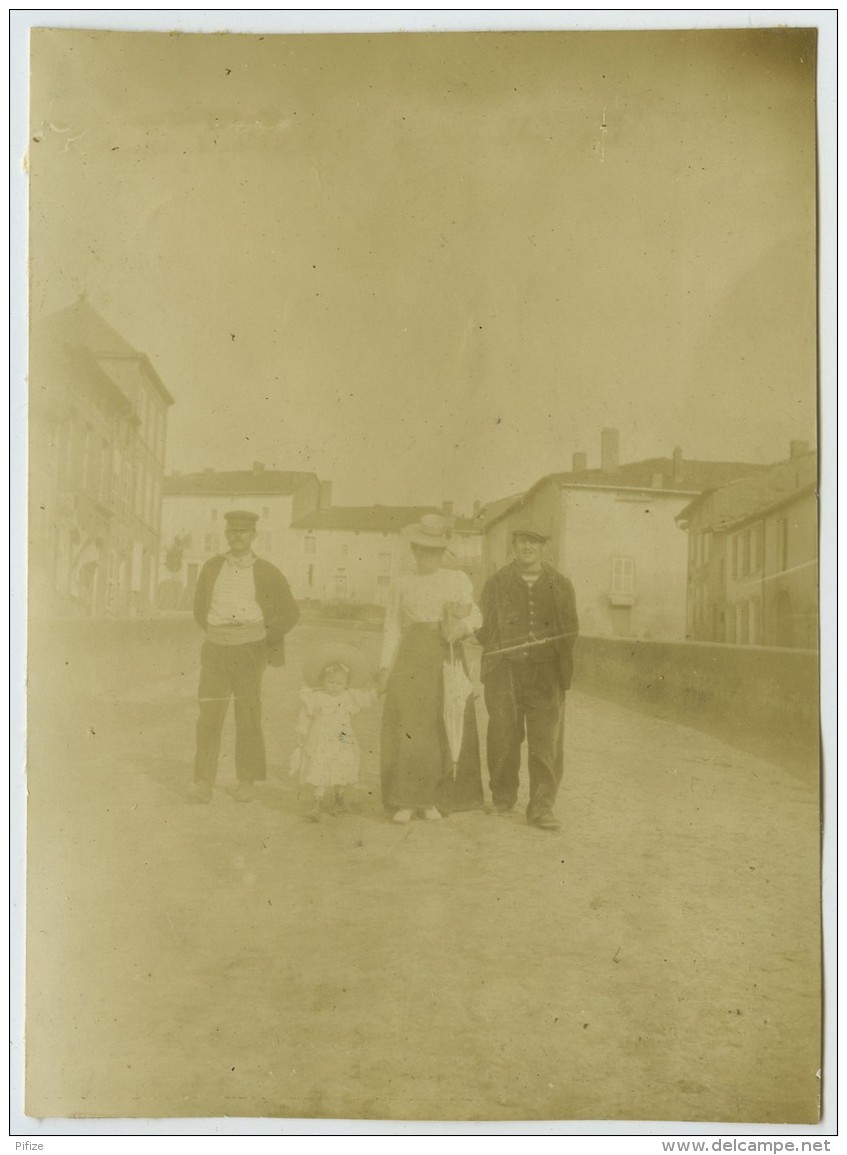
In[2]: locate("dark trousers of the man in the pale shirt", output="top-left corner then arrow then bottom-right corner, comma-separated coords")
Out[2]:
194,641 -> 267,783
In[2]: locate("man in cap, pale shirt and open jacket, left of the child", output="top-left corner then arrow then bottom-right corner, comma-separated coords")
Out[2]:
188,509 -> 300,802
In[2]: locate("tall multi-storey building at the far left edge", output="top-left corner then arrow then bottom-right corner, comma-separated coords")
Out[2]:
29,298 -> 173,617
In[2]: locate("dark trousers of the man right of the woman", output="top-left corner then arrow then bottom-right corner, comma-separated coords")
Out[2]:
485,661 -> 565,822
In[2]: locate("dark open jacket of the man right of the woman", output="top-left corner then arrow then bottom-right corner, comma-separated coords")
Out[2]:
476,561 -> 579,690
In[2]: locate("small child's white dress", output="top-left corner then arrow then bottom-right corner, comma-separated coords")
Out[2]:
291,690 -> 377,787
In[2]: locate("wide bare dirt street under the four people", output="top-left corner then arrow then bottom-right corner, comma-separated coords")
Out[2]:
27,624 -> 820,1123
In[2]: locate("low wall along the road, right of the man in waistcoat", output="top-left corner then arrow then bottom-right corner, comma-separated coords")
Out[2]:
573,636 -> 819,758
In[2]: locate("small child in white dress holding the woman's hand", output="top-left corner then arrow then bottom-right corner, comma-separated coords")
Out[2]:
291,654 -> 377,822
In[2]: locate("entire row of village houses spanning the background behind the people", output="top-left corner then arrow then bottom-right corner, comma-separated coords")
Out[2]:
29,298 -> 818,647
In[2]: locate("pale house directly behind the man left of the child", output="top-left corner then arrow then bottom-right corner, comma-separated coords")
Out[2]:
159,461 -> 323,609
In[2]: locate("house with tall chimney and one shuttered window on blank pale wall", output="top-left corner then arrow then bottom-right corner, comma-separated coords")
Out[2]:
484,430 -> 766,640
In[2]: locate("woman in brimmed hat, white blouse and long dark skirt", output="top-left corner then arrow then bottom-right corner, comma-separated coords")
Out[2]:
379,514 -> 483,822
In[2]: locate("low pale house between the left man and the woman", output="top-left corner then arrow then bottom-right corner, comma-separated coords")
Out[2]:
289,504 -> 462,606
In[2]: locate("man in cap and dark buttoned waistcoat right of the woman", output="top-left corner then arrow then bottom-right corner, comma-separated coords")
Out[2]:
477,521 -> 579,830
